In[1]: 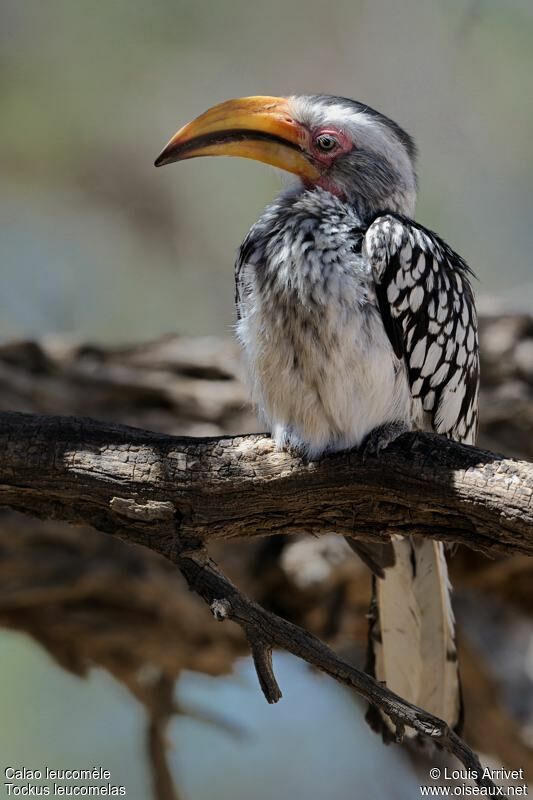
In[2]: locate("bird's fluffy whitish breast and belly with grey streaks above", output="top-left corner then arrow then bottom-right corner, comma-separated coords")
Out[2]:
237,189 -> 411,457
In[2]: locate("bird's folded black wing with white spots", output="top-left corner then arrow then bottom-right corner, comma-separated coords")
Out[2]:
363,213 -> 479,444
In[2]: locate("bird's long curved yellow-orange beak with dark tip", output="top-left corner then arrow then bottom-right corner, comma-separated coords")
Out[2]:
155,96 -> 319,181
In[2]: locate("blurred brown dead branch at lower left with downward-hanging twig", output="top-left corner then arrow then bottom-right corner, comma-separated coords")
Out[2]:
0,512 -> 246,800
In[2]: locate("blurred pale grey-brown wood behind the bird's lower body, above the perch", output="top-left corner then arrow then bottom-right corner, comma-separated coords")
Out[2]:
0,314 -> 533,460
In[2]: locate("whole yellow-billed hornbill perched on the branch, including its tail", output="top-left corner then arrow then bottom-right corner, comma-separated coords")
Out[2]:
155,94 -> 479,738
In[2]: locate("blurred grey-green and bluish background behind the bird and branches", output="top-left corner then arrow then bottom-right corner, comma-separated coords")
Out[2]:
0,0 -> 533,800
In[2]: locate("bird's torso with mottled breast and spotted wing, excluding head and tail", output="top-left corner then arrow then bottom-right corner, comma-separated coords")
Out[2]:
236,184 -> 478,455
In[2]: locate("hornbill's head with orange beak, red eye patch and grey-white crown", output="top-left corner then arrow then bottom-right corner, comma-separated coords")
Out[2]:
155,95 -> 416,216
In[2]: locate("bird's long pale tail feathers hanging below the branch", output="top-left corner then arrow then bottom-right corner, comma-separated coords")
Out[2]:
370,536 -> 461,735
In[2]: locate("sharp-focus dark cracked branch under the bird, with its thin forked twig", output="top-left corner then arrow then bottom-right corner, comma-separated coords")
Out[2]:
0,413 -> 533,796
